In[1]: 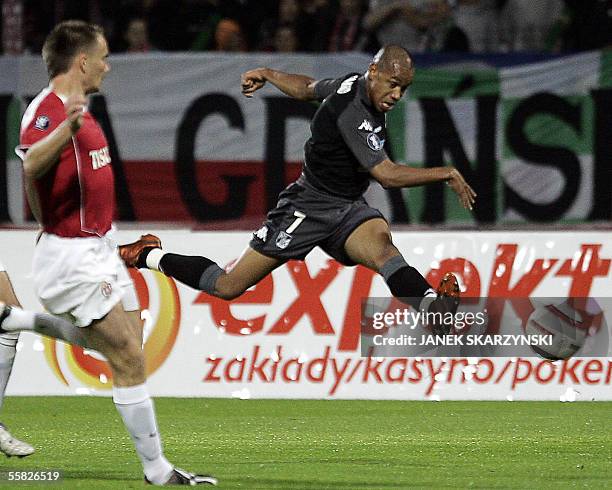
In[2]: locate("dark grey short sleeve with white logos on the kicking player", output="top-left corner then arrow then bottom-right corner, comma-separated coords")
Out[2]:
337,104 -> 389,170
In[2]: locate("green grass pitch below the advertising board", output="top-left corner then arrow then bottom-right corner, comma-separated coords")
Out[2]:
0,397 -> 612,489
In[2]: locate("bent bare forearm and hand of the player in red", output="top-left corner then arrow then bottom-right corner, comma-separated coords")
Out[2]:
23,95 -> 86,179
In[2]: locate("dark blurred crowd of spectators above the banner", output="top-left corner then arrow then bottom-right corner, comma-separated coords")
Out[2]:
0,0 -> 612,54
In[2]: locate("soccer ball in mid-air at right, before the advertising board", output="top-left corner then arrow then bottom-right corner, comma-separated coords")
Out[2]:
525,300 -> 601,361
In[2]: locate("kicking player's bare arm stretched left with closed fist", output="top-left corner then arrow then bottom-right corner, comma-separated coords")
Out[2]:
241,68 -> 317,101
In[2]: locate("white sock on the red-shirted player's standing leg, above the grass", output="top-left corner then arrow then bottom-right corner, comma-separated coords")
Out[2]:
113,384 -> 173,485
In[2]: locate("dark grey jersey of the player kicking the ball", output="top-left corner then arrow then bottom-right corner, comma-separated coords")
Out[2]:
304,73 -> 388,199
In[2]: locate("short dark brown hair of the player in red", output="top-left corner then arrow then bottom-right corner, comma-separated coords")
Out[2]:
42,20 -> 104,79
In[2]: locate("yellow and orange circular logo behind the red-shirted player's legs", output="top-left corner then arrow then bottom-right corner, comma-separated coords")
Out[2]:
44,269 -> 181,390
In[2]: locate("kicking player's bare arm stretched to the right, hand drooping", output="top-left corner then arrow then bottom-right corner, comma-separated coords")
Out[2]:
370,158 -> 476,210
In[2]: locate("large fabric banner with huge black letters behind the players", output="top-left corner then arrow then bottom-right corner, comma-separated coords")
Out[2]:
0,50 -> 612,226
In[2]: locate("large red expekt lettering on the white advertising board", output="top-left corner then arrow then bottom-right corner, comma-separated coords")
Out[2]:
194,243 -> 611,351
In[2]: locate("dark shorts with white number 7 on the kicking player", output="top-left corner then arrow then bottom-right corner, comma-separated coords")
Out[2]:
250,183 -> 385,265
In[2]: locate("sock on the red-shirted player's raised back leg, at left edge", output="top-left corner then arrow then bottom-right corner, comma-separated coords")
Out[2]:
2,306 -> 87,347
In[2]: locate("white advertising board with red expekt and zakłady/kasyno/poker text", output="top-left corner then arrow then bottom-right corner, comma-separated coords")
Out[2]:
0,230 -> 612,401
